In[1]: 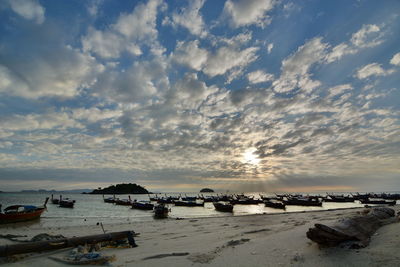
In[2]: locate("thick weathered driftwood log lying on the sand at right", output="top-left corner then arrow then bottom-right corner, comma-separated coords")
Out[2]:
307,207 -> 398,248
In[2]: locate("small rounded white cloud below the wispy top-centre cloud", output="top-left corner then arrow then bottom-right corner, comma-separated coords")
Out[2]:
172,40 -> 208,71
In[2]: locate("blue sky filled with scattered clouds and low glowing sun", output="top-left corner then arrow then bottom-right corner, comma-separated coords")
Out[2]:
0,0 -> 400,192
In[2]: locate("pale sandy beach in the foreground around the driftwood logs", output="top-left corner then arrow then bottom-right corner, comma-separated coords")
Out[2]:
0,205 -> 400,267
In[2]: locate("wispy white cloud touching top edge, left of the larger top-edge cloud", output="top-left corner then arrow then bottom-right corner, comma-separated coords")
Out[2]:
171,0 -> 207,37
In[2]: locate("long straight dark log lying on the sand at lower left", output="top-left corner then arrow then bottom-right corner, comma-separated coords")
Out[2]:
0,231 -> 136,257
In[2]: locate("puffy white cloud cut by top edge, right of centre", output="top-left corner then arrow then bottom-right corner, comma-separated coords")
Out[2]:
224,0 -> 275,27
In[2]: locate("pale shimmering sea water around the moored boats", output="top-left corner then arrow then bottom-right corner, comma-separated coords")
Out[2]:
0,193 -> 382,227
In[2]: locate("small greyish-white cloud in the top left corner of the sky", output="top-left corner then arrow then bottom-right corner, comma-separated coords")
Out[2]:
7,0 -> 45,24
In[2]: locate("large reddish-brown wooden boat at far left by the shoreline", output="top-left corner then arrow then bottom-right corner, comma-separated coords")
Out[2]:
0,197 -> 49,224
